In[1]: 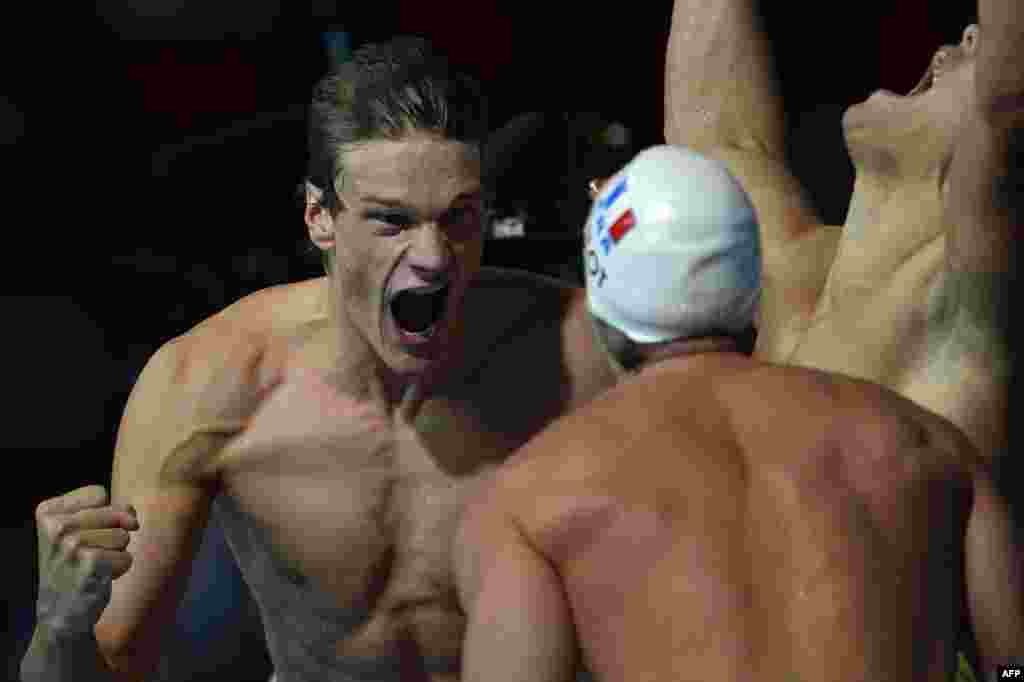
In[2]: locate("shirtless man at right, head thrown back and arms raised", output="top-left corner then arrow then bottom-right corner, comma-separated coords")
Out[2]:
665,0 -> 1024,457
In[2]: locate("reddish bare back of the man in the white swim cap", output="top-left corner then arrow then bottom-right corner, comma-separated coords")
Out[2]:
513,358 -> 971,682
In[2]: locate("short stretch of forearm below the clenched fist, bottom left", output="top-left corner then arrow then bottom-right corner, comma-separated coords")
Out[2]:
22,625 -> 126,682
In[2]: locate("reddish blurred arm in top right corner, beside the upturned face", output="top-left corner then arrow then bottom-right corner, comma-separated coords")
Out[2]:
975,0 -> 1024,127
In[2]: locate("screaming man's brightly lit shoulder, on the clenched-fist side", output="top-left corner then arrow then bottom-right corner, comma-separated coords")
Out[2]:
117,283 -> 319,478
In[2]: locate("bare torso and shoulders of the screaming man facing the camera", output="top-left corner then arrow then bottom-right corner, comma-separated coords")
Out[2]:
97,269 -> 610,682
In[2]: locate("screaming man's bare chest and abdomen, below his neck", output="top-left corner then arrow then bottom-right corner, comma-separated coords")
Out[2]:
199,301 -> 550,681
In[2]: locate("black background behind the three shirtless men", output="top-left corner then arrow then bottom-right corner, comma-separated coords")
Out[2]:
0,0 -> 991,680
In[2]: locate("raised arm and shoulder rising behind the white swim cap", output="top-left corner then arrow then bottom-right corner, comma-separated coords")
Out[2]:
665,0 -> 840,360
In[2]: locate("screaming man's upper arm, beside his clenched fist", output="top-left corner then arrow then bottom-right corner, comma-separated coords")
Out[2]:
96,342 -> 219,672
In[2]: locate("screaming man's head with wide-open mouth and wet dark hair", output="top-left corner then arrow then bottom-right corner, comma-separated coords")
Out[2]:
305,38 -> 487,374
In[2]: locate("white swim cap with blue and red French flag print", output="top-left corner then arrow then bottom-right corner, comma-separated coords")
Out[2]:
584,145 -> 761,343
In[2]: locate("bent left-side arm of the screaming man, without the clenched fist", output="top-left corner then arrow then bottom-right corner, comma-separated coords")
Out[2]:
22,340 -> 253,682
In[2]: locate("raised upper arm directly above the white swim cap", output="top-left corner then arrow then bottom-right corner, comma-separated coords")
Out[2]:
665,0 -> 784,157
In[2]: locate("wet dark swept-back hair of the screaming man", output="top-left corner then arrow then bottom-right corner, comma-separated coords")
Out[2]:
305,37 -> 488,213
